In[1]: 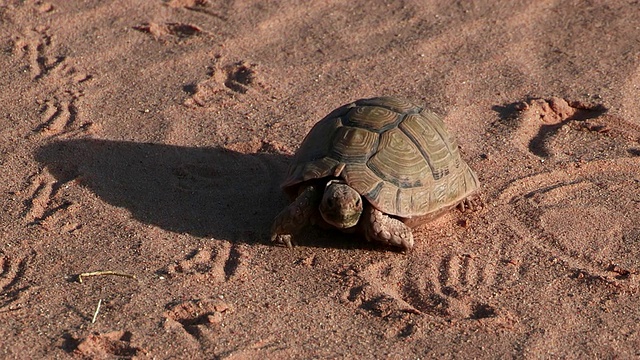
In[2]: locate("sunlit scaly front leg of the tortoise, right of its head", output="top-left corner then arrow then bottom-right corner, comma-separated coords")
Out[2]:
361,205 -> 413,252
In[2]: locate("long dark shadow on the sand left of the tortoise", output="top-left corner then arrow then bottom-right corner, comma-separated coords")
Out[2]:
36,139 -> 286,243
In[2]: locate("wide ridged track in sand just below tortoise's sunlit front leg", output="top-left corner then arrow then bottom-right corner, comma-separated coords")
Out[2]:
342,249 -> 517,320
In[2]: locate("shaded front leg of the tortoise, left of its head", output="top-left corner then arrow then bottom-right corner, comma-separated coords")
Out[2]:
271,186 -> 321,247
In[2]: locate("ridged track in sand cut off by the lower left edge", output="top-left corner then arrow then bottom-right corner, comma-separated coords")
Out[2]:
0,254 -> 34,316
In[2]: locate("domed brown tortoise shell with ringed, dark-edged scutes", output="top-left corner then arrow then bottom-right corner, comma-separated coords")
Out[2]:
282,97 -> 479,222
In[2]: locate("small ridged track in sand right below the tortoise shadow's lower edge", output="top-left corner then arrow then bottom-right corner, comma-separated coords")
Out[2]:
162,242 -> 247,281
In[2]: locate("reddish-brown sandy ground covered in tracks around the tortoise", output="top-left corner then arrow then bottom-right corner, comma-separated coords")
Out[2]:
0,0 -> 640,359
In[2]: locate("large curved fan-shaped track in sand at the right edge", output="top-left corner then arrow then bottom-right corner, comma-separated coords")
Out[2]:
496,157 -> 640,286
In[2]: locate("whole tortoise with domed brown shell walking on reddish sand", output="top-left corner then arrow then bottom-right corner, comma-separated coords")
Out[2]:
271,97 -> 481,252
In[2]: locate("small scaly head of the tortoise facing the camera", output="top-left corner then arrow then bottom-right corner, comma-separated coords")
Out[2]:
320,180 -> 362,229
